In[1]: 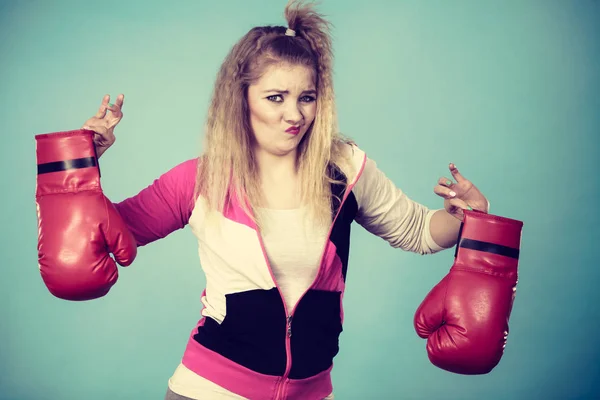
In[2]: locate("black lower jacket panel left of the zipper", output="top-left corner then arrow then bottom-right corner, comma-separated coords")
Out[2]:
194,288 -> 287,375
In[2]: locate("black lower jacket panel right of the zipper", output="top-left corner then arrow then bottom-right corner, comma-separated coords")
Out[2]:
290,289 -> 342,379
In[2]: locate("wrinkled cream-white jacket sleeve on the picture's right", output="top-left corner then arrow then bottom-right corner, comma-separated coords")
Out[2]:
353,158 -> 444,254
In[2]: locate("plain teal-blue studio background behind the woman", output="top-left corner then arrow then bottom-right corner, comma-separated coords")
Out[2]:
0,0 -> 600,400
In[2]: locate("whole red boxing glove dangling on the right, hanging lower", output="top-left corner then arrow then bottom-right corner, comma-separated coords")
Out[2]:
414,210 -> 523,375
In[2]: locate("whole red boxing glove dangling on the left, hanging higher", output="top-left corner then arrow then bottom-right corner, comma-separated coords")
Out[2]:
35,130 -> 137,300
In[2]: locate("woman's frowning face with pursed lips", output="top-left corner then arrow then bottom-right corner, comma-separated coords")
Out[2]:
248,64 -> 317,156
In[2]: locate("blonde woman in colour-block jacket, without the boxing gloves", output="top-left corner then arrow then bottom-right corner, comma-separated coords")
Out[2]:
84,1 -> 488,399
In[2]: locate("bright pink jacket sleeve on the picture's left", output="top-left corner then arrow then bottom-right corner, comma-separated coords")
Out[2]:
113,159 -> 198,246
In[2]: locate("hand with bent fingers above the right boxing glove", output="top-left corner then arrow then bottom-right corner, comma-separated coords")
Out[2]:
433,164 -> 490,221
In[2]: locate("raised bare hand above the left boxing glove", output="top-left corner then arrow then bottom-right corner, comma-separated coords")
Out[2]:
82,94 -> 125,158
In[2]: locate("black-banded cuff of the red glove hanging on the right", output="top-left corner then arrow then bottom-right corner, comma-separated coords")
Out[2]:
452,210 -> 523,279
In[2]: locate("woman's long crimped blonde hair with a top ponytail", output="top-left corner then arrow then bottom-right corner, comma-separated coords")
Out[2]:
195,0 -> 348,230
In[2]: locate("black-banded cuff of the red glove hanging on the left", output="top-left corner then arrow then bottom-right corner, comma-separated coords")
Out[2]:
35,130 -> 101,196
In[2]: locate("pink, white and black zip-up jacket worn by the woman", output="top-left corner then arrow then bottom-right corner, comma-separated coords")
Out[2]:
115,145 -> 442,400
